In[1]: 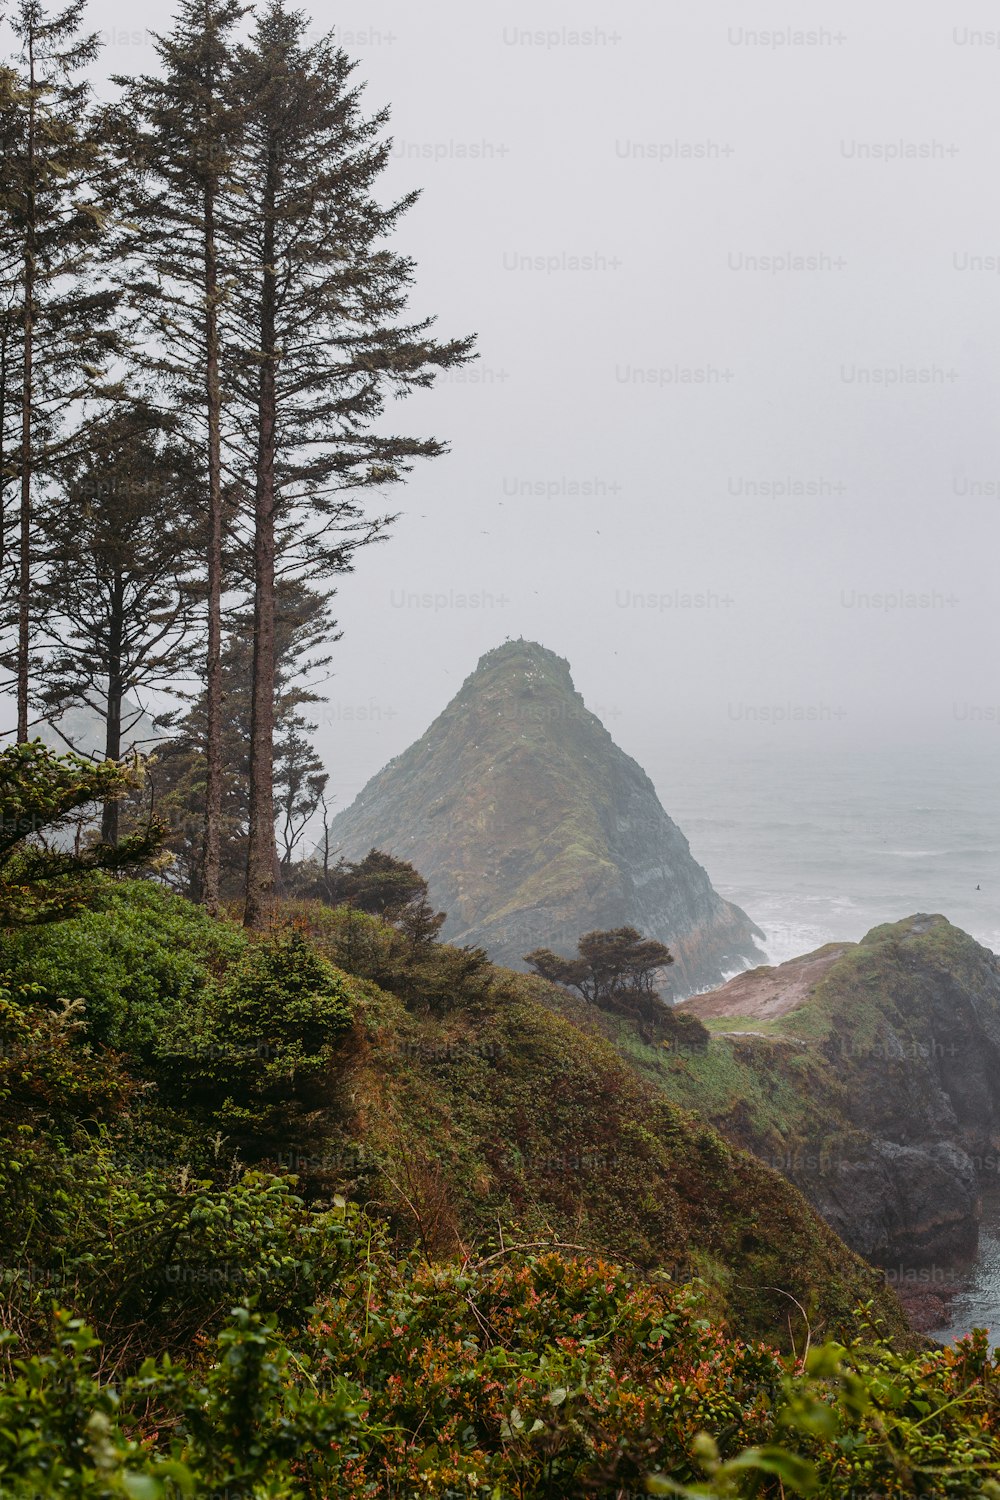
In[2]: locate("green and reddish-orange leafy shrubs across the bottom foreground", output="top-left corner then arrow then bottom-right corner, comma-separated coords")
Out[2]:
0,1254 -> 1000,1500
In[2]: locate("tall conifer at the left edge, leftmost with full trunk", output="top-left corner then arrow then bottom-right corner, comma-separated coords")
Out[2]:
0,0 -> 117,741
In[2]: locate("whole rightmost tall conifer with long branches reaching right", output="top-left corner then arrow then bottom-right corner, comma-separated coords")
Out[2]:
223,0 -> 471,927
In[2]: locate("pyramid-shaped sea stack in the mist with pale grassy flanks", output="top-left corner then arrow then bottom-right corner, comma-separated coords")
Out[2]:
331,641 -> 762,995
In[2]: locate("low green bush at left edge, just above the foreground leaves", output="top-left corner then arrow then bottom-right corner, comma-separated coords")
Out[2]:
0,1131 -> 359,1361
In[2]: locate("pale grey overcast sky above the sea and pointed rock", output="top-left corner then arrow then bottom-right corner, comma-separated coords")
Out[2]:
58,0 -> 1000,806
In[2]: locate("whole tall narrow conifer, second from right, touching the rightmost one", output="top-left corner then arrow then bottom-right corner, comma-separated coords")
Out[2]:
118,0 -> 244,911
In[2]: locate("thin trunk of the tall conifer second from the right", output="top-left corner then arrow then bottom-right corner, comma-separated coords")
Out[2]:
202,172 -> 222,915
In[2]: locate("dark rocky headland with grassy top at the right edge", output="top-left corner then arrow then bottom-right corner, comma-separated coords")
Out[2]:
663,917 -> 1000,1268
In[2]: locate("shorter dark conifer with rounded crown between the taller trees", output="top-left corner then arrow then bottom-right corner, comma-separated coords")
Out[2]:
37,404 -> 195,845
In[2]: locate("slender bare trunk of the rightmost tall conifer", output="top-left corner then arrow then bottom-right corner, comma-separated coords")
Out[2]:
243,150 -> 277,930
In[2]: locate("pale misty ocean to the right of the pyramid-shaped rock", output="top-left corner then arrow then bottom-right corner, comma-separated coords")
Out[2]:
645,747 -> 1000,963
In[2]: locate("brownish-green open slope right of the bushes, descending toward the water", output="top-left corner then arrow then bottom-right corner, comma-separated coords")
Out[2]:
293,906 -> 904,1356
